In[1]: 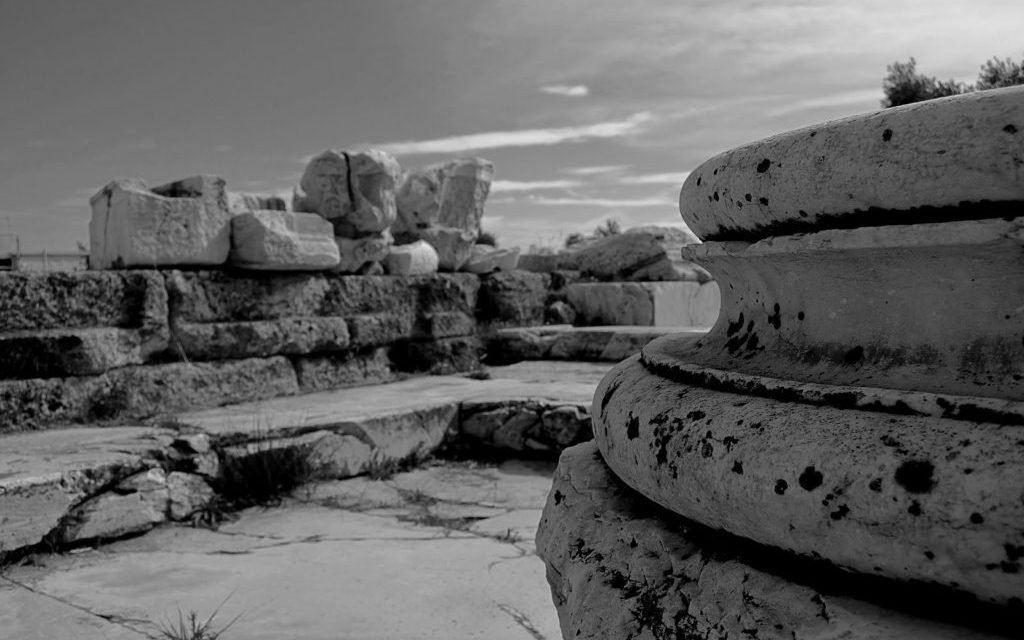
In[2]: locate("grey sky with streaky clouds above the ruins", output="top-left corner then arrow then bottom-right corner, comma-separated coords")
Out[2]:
0,0 -> 1024,251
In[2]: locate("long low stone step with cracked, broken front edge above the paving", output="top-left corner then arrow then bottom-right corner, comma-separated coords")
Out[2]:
0,362 -> 607,561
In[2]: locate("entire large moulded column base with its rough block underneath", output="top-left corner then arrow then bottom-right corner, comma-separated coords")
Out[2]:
537,83 -> 1024,640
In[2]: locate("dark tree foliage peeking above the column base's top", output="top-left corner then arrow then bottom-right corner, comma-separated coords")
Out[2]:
882,51 -> 1024,108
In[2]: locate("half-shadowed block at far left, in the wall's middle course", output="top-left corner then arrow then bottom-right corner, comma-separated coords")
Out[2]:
0,328 -> 143,378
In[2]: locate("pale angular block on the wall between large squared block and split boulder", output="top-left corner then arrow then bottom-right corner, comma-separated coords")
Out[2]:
230,211 -> 341,271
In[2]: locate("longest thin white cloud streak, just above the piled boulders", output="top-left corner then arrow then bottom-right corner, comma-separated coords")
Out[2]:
367,112 -> 652,156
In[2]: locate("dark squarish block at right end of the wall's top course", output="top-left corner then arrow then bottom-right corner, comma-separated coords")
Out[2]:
476,271 -> 551,327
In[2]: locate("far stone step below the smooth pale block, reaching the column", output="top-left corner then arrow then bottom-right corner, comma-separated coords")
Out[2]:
487,325 -> 709,365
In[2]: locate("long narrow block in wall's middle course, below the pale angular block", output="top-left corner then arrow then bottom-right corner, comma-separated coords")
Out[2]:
164,317 -> 349,360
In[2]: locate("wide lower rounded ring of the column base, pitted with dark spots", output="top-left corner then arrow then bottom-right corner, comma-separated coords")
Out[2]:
593,354 -> 1024,604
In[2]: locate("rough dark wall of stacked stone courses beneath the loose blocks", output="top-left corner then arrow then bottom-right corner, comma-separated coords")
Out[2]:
0,270 -> 550,432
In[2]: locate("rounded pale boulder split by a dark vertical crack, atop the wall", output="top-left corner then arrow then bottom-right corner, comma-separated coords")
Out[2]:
295,150 -> 400,238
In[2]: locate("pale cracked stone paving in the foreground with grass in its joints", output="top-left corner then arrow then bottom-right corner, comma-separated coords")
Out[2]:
0,461 -> 560,640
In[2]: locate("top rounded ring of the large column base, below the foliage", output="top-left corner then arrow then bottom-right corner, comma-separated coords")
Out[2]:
679,87 -> 1024,239
